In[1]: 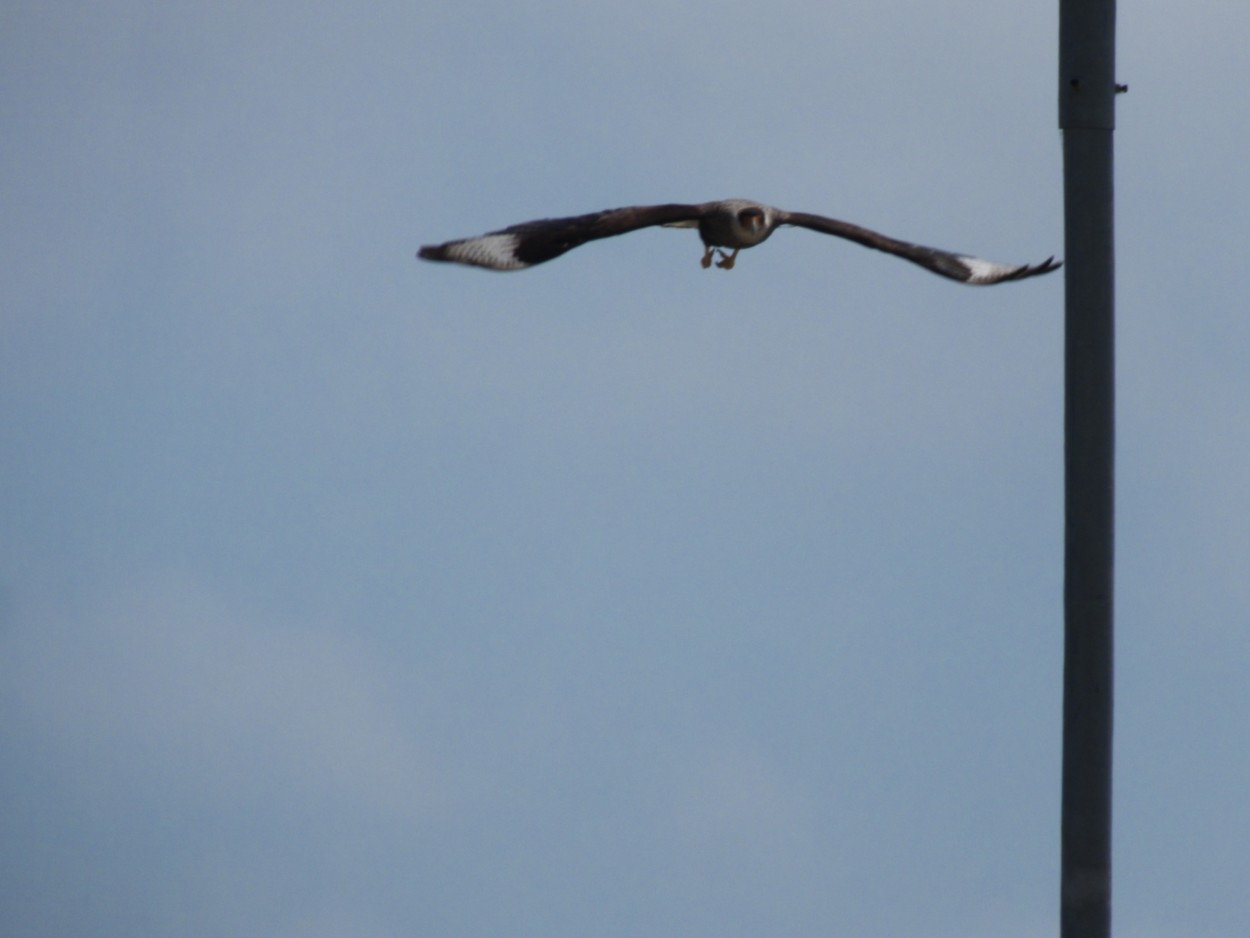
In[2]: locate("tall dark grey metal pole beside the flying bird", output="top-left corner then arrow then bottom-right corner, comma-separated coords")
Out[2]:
1059,0 -> 1118,938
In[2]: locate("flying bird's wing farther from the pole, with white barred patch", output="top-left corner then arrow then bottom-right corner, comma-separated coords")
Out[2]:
416,204 -> 703,270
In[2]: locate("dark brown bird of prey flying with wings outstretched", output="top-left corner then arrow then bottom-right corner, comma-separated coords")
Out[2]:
418,199 -> 1063,285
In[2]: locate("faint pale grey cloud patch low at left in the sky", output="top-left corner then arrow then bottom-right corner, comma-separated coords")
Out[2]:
5,578 -> 439,819
